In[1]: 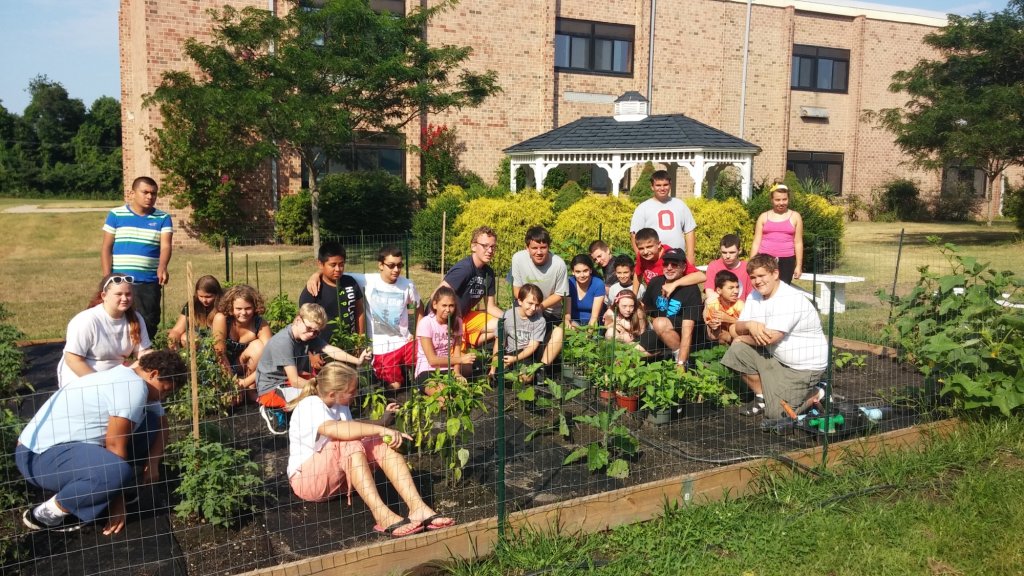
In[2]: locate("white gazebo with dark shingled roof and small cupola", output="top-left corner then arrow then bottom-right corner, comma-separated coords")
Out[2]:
504,92 -> 761,201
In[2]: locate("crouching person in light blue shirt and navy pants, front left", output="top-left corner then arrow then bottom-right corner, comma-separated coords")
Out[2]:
14,351 -> 187,535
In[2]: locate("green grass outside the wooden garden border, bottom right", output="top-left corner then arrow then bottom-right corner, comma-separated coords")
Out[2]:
443,418 -> 1024,576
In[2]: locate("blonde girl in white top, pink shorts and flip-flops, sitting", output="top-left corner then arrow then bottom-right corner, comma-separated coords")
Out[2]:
288,362 -> 455,538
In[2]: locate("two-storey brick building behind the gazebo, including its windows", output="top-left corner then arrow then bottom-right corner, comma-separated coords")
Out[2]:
120,0 -> 999,236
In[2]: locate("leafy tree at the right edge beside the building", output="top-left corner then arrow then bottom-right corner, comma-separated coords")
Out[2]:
864,0 -> 1024,224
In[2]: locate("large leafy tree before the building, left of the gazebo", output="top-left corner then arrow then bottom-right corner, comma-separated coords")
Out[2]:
147,0 -> 499,251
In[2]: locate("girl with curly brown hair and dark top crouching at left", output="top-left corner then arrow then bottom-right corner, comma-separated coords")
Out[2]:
211,284 -> 273,402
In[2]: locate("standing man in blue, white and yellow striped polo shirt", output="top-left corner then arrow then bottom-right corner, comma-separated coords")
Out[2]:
99,176 -> 174,340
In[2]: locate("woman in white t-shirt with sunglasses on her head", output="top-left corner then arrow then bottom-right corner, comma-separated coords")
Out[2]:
57,274 -> 151,387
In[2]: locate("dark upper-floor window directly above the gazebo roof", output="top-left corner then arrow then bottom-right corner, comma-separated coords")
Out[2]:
555,18 -> 633,75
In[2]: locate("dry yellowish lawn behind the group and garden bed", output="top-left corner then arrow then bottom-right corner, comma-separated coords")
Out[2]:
0,198 -> 1024,341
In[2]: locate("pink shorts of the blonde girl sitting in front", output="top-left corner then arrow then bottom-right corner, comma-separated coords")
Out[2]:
288,436 -> 388,505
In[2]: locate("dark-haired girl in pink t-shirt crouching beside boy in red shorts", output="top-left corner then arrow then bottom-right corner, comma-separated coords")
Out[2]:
416,286 -> 476,395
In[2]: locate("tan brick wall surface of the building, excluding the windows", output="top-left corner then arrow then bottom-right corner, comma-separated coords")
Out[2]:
120,0 -> 1007,241
